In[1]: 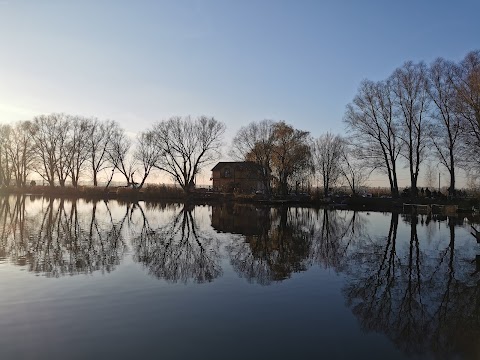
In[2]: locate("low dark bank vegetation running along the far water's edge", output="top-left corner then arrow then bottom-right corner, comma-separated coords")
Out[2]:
0,184 -> 480,214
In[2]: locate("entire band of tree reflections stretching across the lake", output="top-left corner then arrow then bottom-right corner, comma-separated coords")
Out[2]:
0,197 -> 480,358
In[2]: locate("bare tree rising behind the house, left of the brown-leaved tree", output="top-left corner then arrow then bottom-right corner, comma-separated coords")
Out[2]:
230,120 -> 275,193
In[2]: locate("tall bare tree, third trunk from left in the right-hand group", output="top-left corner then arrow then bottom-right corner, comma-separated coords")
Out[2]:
427,59 -> 461,195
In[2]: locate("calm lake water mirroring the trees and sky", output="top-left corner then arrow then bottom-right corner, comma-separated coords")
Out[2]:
0,197 -> 480,359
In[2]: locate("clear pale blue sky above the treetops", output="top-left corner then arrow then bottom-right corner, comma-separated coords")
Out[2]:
0,0 -> 480,184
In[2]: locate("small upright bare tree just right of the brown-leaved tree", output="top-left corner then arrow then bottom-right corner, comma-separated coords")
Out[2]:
312,132 -> 345,196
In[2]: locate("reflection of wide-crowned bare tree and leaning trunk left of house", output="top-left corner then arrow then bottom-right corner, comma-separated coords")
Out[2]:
132,205 -> 222,283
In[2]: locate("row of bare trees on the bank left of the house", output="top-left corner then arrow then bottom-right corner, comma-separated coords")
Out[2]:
0,113 -> 225,192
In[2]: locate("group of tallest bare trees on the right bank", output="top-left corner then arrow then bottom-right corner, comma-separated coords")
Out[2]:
344,50 -> 480,196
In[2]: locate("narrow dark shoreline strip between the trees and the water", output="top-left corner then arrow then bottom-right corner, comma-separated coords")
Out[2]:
0,186 -> 480,213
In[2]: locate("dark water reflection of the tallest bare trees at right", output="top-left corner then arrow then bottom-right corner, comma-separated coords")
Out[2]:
344,214 -> 480,358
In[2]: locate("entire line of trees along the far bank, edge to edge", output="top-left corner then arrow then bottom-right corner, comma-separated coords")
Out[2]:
0,50 -> 480,197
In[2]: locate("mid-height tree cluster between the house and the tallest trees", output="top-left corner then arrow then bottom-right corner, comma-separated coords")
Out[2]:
230,120 -> 369,195
